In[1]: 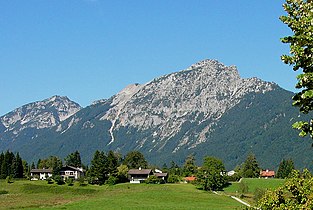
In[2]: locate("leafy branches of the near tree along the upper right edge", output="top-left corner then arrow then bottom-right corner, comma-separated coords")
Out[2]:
280,0 -> 313,138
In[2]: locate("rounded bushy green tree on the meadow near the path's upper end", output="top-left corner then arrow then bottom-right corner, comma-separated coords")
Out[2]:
197,157 -> 226,191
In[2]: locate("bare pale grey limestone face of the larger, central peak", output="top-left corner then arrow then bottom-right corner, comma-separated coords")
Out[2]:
97,60 -> 277,152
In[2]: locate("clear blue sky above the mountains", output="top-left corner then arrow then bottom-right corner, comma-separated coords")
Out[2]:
0,0 -> 296,116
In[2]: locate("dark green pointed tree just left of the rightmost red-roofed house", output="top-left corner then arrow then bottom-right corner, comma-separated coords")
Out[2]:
241,153 -> 260,178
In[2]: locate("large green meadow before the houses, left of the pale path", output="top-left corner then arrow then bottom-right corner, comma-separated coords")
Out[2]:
0,180 -> 242,209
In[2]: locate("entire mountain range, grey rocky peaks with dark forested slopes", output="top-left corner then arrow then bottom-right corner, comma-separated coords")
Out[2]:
0,60 -> 312,169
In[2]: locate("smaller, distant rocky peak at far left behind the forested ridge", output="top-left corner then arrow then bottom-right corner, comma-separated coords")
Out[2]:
0,96 -> 81,149
